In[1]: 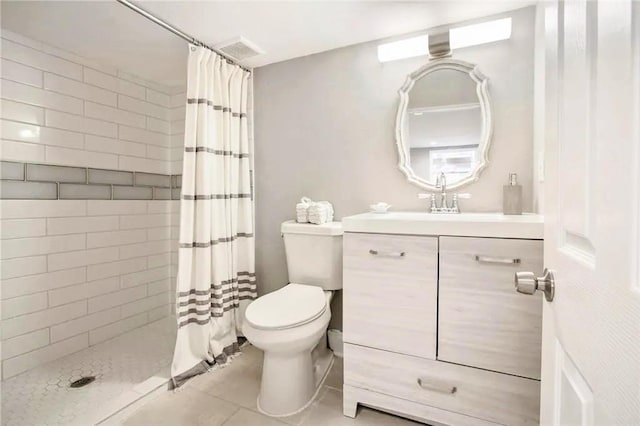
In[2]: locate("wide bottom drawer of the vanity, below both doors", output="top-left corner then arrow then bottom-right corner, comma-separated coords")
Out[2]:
344,344 -> 540,425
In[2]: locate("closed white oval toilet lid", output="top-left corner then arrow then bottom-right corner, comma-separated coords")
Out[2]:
245,283 -> 327,329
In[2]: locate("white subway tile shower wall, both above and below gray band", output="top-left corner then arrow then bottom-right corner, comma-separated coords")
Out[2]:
0,29 -> 186,379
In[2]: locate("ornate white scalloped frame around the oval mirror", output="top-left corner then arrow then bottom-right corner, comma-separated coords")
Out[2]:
396,58 -> 493,191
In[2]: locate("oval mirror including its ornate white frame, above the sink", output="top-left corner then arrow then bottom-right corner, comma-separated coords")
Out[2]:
396,59 -> 492,190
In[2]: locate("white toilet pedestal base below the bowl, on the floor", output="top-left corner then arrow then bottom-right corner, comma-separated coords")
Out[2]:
257,342 -> 333,417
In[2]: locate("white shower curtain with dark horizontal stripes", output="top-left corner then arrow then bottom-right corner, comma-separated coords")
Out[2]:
171,45 -> 256,387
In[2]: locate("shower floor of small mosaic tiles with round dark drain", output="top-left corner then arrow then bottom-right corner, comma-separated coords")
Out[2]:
1,316 -> 176,426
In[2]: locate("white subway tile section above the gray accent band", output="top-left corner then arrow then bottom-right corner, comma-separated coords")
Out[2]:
0,30 -> 186,174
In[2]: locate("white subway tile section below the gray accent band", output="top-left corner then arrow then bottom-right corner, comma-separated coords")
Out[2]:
0,200 -> 179,378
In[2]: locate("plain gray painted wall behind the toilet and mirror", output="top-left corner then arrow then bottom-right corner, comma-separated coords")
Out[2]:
254,7 -> 535,327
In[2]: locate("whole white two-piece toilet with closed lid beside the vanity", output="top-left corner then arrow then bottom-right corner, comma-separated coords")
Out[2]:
242,221 -> 342,417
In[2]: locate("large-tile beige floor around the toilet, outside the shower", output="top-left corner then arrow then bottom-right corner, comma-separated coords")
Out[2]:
104,345 -> 418,426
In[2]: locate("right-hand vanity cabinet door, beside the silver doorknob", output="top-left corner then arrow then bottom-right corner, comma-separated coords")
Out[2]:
438,237 -> 543,379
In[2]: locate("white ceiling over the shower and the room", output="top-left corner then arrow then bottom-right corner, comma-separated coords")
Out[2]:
2,0 -> 534,86
